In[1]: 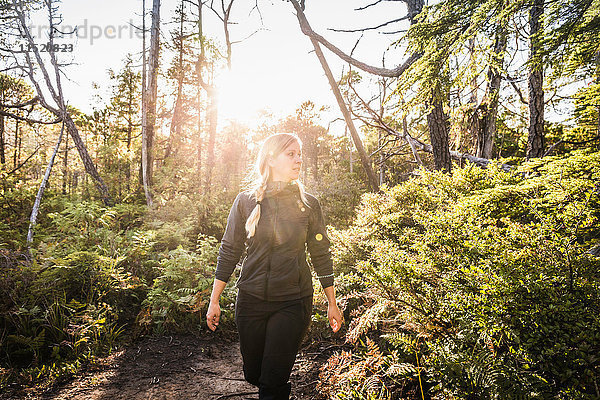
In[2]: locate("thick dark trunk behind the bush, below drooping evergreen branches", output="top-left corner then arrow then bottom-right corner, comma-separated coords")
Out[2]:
427,90 -> 452,172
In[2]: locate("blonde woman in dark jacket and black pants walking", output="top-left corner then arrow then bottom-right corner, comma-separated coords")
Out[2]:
206,133 -> 342,400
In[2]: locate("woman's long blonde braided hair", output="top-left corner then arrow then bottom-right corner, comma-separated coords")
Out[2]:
246,133 -> 308,238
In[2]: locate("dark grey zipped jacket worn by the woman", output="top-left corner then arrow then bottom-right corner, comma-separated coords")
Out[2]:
215,182 -> 333,301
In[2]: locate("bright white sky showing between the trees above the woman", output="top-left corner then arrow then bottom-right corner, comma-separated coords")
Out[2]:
25,0 -> 405,131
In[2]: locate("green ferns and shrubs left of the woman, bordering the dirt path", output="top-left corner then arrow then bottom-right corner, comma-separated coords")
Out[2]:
0,189 -> 234,387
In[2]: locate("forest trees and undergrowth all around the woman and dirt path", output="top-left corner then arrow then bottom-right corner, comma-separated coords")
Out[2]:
0,0 -> 600,400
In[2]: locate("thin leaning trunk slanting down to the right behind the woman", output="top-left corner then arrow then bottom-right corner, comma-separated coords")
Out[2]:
310,37 -> 379,192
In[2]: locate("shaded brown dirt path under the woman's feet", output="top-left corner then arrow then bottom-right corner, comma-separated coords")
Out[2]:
0,336 -> 339,400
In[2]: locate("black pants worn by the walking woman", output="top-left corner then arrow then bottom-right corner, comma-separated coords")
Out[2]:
235,291 -> 312,400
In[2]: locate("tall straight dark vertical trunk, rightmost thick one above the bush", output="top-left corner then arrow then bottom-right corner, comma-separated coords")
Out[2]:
527,0 -> 545,158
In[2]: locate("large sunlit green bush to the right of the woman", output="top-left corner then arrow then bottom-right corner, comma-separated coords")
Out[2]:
329,151 -> 600,399
